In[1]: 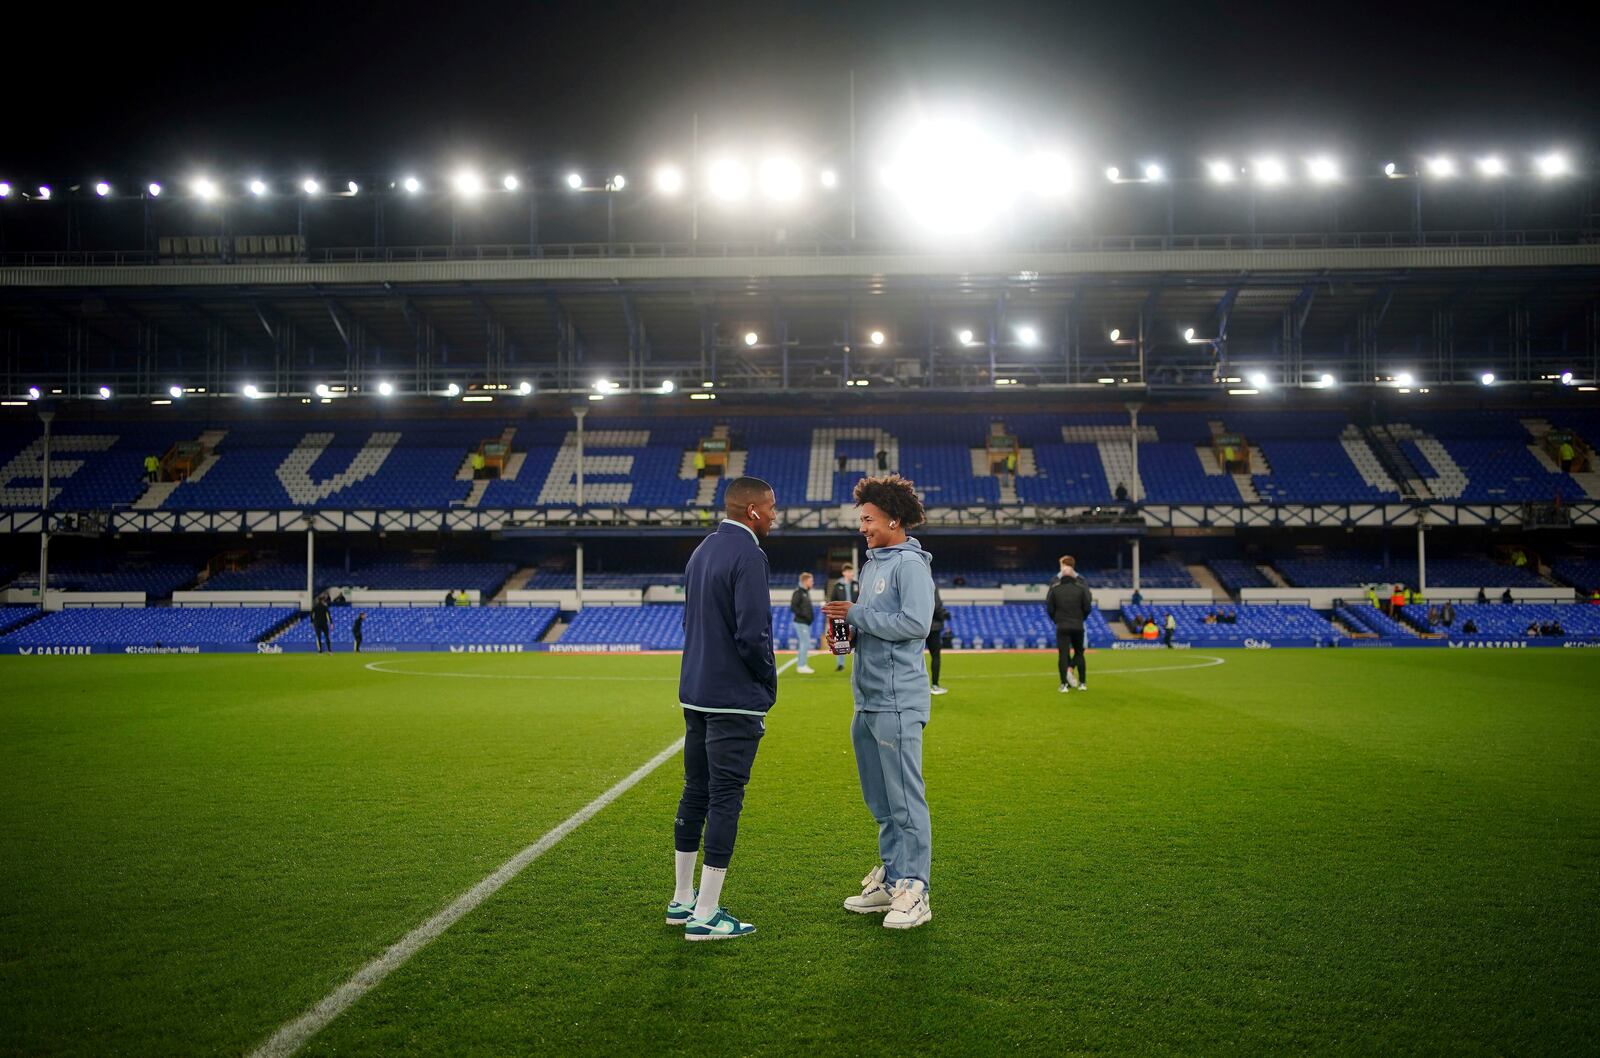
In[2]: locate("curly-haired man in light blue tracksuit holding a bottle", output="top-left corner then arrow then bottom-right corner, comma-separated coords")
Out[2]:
822,474 -> 933,930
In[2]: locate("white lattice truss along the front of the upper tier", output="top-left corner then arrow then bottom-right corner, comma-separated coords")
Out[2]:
0,501 -> 1600,538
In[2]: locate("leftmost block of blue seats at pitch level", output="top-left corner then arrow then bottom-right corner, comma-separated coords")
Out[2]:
0,607 -> 299,647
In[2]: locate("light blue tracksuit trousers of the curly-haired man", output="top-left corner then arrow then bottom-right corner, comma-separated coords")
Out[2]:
850,711 -> 933,887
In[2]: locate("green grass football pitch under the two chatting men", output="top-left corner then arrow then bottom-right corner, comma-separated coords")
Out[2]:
0,650 -> 1600,1055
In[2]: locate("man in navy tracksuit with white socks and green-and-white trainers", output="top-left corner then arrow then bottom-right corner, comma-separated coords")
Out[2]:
667,477 -> 778,941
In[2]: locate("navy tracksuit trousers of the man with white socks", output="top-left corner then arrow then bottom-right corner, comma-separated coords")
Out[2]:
672,709 -> 766,869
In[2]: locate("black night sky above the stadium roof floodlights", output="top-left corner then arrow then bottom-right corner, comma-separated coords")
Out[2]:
0,2 -> 1600,179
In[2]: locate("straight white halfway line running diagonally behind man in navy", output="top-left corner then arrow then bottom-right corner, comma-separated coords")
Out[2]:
250,658 -> 795,1058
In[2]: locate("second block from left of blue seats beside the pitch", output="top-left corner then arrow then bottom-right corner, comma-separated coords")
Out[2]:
272,607 -> 558,647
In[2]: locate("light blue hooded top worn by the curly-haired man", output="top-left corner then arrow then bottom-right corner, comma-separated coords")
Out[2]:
850,536 -> 933,720
